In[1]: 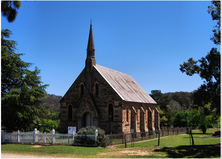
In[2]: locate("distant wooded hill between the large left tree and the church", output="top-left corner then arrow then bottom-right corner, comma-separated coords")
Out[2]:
41,94 -> 62,113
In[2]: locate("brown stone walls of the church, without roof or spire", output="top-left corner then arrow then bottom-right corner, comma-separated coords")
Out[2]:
60,67 -> 159,133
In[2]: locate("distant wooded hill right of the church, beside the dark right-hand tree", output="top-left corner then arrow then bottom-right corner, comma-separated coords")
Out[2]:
164,92 -> 193,109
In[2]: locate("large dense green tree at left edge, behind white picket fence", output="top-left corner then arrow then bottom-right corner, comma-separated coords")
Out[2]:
1,29 -> 48,131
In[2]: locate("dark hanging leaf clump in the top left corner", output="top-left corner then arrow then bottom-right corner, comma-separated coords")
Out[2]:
1,1 -> 21,23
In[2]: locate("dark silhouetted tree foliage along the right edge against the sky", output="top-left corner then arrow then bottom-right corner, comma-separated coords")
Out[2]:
180,1 -> 221,115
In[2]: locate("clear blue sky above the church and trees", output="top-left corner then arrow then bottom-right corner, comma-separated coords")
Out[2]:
1,1 -> 219,96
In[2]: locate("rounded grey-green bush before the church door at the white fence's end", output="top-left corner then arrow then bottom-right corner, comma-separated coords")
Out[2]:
75,126 -> 109,147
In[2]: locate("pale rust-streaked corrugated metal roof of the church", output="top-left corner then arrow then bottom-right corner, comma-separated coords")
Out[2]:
94,64 -> 156,104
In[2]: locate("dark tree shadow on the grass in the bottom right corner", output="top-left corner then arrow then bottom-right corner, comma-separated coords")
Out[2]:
154,143 -> 220,158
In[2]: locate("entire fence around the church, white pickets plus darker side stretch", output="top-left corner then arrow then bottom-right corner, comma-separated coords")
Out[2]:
1,128 -> 189,145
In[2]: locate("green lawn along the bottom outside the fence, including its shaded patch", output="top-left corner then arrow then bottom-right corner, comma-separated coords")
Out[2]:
1,129 -> 220,158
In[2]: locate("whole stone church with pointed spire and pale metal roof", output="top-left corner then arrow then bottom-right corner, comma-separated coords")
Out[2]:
60,24 -> 159,134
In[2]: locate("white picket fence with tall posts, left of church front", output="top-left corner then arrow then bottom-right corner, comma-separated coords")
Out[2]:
1,128 -> 98,145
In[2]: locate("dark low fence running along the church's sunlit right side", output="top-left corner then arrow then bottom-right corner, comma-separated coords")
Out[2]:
105,128 -> 189,145
